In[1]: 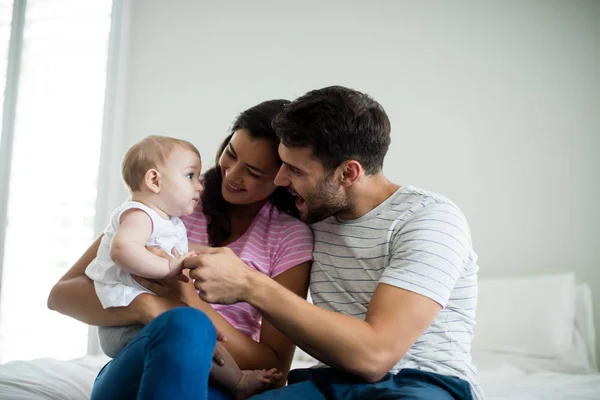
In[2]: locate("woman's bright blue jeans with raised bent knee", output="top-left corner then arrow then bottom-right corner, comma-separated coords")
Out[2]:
91,307 -> 233,400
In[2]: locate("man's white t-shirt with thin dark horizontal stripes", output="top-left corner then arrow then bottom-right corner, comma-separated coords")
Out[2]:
310,186 -> 482,399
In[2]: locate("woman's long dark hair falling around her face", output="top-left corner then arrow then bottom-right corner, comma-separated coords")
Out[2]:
201,100 -> 298,246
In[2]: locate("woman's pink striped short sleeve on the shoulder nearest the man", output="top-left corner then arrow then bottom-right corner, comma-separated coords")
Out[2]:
271,219 -> 313,278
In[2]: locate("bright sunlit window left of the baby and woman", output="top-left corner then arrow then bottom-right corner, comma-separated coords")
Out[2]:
0,0 -> 112,362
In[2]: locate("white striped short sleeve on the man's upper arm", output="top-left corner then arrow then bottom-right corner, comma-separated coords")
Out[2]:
379,203 -> 472,307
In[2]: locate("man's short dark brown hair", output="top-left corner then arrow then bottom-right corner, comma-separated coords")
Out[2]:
273,86 -> 391,175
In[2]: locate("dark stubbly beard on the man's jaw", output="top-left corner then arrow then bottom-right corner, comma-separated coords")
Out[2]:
302,177 -> 351,224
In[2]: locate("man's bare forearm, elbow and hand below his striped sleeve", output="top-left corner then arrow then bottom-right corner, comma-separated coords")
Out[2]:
189,248 -> 441,382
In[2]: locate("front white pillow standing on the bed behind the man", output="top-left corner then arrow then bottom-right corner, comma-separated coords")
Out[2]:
473,273 -> 576,358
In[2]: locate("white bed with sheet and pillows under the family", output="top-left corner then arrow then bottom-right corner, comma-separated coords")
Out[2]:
0,274 -> 600,400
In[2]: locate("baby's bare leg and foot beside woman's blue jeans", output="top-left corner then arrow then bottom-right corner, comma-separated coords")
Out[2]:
210,342 -> 281,399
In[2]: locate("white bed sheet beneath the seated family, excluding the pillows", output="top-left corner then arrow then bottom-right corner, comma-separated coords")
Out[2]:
0,356 -> 600,400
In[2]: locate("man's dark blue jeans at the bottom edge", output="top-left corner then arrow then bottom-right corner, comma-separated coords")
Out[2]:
250,368 -> 473,400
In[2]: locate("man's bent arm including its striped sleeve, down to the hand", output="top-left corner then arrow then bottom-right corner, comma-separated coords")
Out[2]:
191,205 -> 471,382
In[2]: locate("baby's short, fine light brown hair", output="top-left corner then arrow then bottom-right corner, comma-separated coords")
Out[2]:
121,136 -> 200,192
